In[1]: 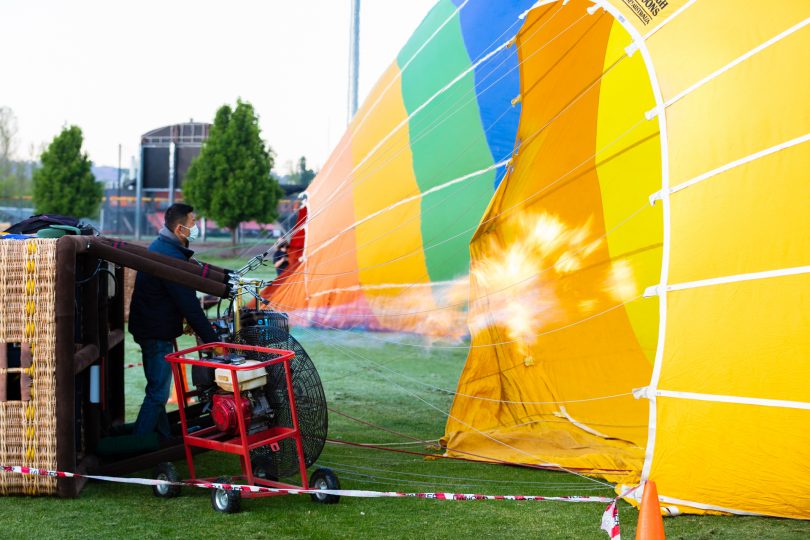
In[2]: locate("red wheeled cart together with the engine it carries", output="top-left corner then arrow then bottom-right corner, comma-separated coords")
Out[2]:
153,343 -> 340,513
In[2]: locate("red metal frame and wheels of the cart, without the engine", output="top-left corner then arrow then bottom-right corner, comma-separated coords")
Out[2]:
153,343 -> 340,513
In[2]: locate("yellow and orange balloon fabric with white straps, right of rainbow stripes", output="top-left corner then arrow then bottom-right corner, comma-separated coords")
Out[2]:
444,0 -> 810,519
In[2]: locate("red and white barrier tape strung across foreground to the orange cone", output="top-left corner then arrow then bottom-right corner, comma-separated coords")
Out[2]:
0,465 -> 621,540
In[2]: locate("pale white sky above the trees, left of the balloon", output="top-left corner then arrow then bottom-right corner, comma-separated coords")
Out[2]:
0,0 -> 436,173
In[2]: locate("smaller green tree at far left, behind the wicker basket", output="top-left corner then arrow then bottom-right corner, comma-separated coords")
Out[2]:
34,126 -> 104,218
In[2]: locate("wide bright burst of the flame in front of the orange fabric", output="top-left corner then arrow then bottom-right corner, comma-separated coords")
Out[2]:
469,213 -> 637,361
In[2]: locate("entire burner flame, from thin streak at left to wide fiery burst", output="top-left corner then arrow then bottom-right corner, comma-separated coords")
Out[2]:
284,209 -> 638,344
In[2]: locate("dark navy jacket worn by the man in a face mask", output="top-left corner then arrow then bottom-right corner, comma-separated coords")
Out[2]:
129,228 -> 217,343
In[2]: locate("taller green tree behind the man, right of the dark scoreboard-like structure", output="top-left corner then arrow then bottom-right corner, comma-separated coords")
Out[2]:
183,100 -> 283,244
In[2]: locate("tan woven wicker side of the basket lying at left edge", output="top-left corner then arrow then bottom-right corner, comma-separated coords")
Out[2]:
0,239 -> 57,495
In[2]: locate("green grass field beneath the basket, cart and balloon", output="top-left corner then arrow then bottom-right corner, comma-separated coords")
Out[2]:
0,251 -> 810,539
